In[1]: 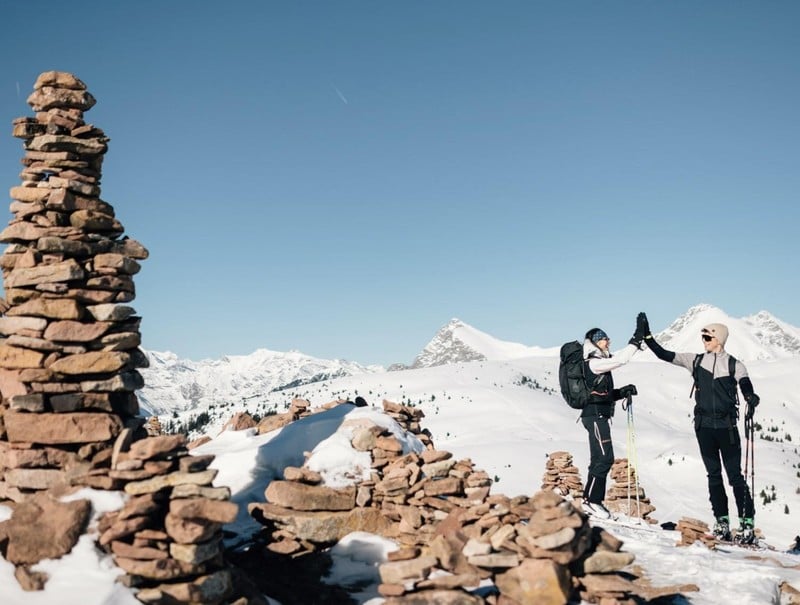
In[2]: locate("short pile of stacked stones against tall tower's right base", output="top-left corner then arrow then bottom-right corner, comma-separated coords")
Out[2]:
98,431 -> 238,603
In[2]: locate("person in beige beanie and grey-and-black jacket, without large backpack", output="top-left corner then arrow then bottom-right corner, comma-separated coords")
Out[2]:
637,313 -> 759,544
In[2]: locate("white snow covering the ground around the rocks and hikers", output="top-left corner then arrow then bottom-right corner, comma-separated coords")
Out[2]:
0,307 -> 800,605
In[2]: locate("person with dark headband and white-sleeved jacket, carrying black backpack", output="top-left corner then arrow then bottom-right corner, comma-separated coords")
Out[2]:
581,328 -> 644,519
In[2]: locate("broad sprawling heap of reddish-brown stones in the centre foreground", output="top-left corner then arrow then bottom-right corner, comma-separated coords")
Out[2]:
248,401 -> 693,605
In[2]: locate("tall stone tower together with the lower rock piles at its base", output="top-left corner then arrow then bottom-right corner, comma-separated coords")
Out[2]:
0,71 -> 247,603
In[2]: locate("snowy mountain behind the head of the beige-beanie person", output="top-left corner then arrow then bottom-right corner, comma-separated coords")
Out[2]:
651,304 -> 800,361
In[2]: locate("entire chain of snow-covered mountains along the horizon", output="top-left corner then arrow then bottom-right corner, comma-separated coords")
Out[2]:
139,304 -> 800,415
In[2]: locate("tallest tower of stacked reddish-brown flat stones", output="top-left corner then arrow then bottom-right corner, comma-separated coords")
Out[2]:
0,72 -> 148,501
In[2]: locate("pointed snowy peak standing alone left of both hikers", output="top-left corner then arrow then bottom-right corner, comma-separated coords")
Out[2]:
411,319 -> 545,369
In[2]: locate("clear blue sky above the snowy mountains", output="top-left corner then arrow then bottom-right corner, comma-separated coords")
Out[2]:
0,0 -> 800,365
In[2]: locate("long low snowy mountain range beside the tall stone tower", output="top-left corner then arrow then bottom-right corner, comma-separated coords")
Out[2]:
138,349 -> 384,415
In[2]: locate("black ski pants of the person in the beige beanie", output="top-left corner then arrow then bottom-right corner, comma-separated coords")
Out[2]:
695,427 -> 755,519
